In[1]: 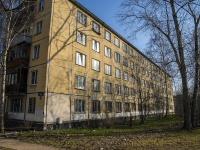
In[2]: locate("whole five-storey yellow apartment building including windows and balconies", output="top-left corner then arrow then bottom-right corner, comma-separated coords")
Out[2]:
6,0 -> 174,129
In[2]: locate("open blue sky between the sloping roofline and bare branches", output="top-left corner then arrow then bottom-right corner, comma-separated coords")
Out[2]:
77,0 -> 149,52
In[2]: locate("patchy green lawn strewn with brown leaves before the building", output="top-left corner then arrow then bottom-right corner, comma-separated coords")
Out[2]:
19,116 -> 200,150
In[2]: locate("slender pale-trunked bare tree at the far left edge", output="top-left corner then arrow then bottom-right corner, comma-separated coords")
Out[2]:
0,0 -> 36,132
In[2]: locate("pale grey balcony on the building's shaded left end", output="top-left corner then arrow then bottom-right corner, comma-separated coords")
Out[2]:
11,35 -> 32,47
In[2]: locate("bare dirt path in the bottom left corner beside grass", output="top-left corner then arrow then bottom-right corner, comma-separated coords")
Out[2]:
0,137 -> 62,150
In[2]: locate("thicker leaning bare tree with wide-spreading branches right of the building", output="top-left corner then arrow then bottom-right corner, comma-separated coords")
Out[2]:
118,0 -> 199,130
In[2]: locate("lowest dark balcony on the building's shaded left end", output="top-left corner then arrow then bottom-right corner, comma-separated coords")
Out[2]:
6,84 -> 27,95
